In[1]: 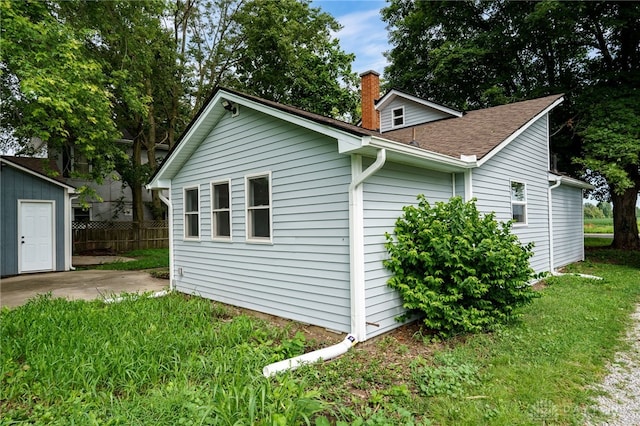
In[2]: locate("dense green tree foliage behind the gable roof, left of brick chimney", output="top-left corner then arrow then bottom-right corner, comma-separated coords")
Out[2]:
231,0 -> 358,118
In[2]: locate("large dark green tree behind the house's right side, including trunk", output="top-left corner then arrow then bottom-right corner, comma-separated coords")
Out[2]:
383,0 -> 640,249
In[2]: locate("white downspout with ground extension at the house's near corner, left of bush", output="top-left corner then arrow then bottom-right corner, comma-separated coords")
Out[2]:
262,148 -> 387,377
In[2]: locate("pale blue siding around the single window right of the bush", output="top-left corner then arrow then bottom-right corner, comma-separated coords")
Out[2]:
472,116 -> 549,272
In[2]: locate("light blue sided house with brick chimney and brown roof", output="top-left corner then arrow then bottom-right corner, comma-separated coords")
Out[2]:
148,72 -> 588,341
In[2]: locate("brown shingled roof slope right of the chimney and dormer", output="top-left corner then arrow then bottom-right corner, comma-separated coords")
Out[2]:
382,95 -> 563,159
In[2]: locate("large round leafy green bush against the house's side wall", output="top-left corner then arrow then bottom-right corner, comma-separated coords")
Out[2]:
384,195 -> 536,337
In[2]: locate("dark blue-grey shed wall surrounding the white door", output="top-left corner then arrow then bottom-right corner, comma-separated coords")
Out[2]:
0,165 -> 67,276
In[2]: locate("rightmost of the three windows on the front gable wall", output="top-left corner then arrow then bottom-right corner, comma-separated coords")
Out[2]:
246,174 -> 271,242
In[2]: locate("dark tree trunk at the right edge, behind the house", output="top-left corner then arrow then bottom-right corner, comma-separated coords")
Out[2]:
611,185 -> 640,250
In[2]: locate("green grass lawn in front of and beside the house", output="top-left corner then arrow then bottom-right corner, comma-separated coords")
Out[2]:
0,248 -> 640,426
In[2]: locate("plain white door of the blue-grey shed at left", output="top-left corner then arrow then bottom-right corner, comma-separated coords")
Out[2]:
18,201 -> 54,273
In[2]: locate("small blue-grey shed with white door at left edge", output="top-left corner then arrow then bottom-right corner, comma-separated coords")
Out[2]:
0,156 -> 74,276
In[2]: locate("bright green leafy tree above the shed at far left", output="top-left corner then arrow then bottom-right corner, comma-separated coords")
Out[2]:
0,0 -> 122,187
